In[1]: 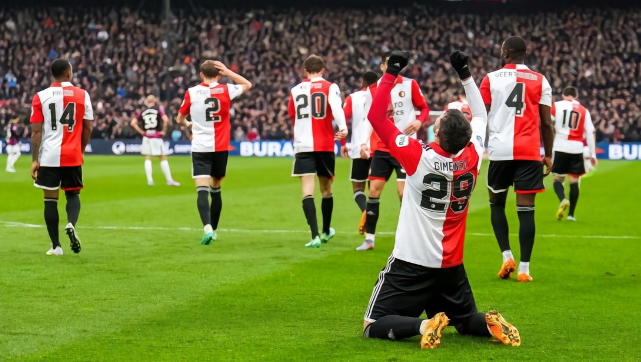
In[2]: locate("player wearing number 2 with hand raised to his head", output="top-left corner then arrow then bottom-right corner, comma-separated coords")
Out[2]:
176,60 -> 252,245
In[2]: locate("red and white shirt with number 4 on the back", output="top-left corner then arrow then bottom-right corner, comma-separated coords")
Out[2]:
481,64 -> 552,161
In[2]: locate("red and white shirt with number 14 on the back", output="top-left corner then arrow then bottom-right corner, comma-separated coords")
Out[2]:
31,82 -> 93,167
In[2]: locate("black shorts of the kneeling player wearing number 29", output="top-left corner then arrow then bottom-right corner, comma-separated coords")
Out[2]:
365,256 -> 477,325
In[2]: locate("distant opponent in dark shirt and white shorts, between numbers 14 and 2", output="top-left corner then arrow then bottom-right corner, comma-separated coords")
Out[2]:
131,95 -> 180,186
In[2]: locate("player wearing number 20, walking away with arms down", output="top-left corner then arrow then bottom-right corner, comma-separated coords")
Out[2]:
289,55 -> 347,248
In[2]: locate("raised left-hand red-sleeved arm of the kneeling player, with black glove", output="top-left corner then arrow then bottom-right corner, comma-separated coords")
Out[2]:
367,51 -> 423,176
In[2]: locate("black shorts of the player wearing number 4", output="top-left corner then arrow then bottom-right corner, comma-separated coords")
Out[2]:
487,160 -> 545,194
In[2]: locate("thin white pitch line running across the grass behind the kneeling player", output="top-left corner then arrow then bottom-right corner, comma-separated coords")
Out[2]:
0,221 -> 641,239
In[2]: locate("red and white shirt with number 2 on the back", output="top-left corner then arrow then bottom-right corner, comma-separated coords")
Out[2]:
179,82 -> 243,152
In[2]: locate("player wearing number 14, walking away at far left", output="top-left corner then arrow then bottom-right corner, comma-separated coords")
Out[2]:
31,59 -> 93,256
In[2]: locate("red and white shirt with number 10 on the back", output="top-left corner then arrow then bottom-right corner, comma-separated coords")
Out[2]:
552,100 -> 596,157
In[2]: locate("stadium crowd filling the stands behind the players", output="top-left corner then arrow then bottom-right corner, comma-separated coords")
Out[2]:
0,5 -> 641,142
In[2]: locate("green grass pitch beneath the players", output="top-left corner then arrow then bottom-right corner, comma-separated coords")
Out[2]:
0,156 -> 641,362
